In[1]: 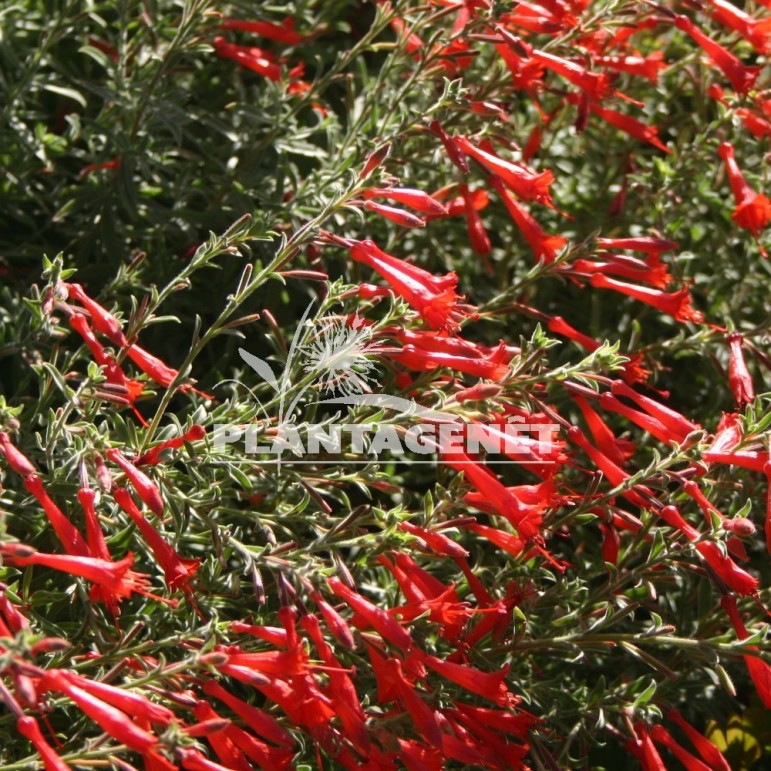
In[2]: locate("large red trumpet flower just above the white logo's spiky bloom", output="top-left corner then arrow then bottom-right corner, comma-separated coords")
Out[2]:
349,240 -> 464,329
